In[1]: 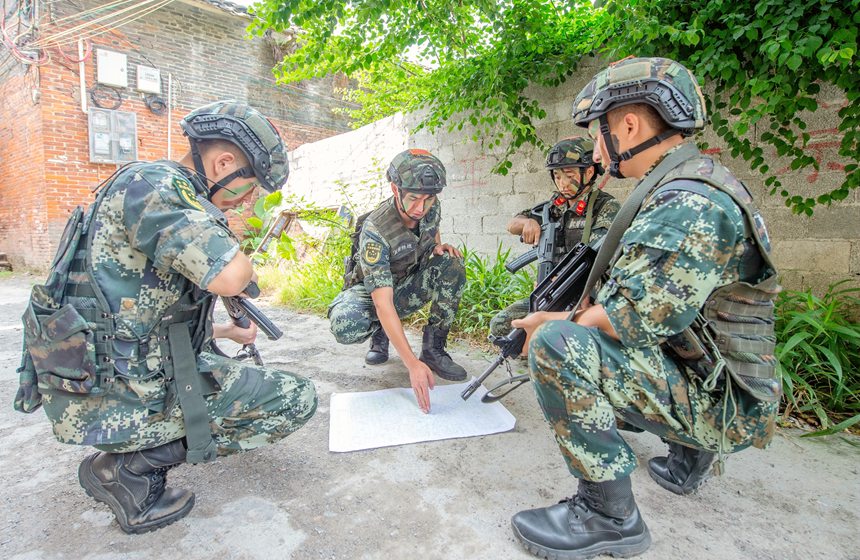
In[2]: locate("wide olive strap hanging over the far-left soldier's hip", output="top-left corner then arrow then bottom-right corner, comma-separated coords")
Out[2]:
167,323 -> 216,463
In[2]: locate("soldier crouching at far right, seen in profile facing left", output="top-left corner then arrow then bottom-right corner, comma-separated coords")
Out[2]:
512,58 -> 780,558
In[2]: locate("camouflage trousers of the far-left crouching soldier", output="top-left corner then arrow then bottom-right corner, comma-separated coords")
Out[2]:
43,352 -> 317,456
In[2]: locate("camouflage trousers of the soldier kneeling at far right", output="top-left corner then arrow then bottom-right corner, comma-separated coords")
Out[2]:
529,321 -> 777,482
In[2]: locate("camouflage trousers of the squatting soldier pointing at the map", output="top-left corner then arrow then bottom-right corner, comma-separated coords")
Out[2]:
328,253 -> 466,344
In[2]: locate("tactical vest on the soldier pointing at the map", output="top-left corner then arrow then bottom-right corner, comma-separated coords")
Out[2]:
344,197 -> 439,288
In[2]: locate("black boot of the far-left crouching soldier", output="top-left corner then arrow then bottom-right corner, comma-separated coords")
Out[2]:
78,440 -> 194,533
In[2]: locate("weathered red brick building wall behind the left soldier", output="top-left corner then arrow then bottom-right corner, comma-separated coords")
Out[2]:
0,0 -> 348,268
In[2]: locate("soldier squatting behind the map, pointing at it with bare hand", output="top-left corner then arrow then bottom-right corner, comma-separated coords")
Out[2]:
328,149 -> 466,412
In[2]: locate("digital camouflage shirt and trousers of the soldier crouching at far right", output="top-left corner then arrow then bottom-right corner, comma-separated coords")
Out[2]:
529,144 -> 778,482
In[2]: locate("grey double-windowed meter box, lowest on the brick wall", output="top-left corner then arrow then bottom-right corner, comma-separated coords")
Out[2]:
88,107 -> 137,163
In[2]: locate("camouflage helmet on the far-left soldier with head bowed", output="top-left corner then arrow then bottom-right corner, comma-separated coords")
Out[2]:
180,100 -> 290,193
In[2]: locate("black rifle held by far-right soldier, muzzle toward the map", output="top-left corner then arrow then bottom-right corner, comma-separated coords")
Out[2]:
460,239 -> 602,403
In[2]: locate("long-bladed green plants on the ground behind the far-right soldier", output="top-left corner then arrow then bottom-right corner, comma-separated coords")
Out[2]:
776,280 -> 860,435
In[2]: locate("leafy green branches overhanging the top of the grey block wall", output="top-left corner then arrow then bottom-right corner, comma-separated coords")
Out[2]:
251,0 -> 860,210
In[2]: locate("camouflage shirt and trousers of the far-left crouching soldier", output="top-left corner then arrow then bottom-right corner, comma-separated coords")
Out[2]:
25,162 -> 317,455
